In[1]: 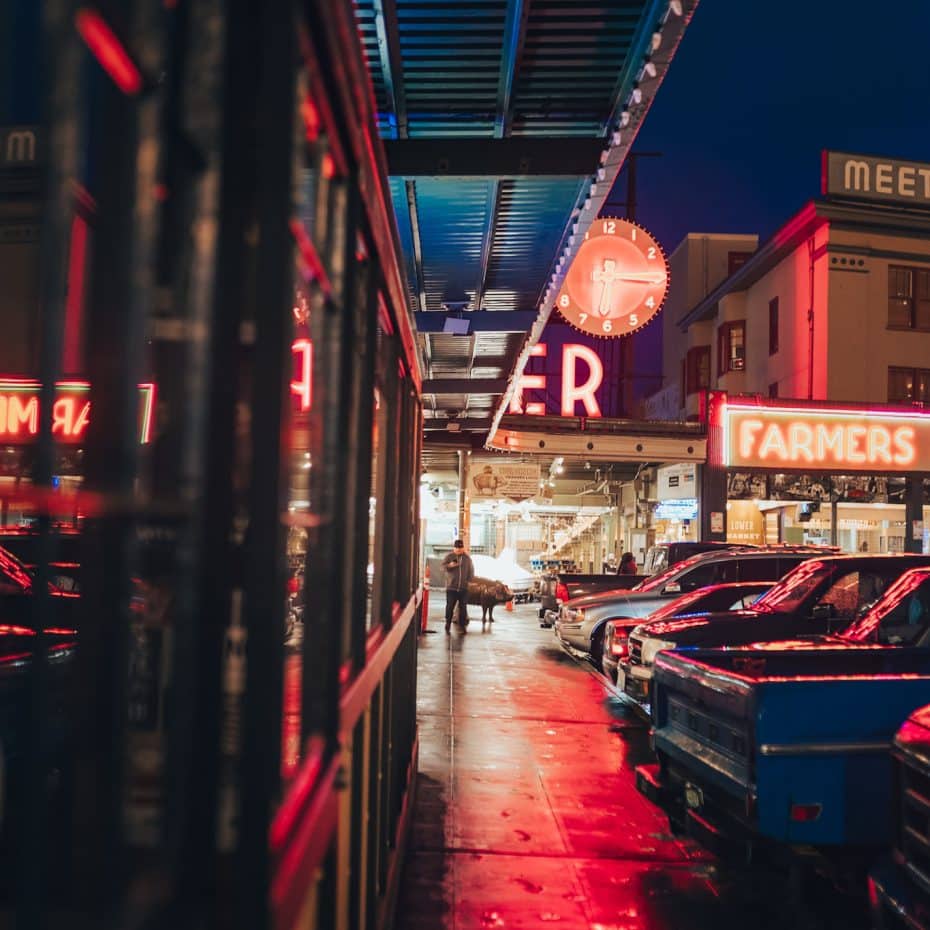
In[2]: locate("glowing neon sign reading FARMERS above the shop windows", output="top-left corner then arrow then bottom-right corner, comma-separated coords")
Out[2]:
721,404 -> 930,472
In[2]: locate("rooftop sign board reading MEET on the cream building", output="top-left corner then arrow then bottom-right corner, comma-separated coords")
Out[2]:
821,151 -> 930,208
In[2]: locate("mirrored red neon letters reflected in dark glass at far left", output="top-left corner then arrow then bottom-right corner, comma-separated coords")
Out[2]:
0,378 -> 155,443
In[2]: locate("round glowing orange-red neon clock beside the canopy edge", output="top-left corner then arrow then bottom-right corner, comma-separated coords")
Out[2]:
555,217 -> 668,338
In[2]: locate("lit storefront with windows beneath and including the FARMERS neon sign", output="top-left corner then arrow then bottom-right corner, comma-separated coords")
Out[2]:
703,393 -> 930,552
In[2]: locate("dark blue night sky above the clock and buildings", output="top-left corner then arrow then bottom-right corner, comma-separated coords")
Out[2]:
604,0 -> 930,251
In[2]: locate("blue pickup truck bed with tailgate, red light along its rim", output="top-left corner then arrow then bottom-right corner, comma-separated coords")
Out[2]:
636,644 -> 930,870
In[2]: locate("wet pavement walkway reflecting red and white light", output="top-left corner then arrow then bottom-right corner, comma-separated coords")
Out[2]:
396,590 -> 868,930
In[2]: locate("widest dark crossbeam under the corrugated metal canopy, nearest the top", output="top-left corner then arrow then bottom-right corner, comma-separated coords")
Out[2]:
384,136 -> 604,178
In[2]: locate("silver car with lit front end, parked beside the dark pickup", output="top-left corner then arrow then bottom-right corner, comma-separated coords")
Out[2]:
555,546 -> 835,668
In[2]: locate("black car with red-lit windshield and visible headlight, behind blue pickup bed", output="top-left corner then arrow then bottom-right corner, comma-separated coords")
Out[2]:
617,554 -> 930,702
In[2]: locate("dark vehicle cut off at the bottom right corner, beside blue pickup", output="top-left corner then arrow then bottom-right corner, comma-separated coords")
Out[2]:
869,707 -> 930,930
